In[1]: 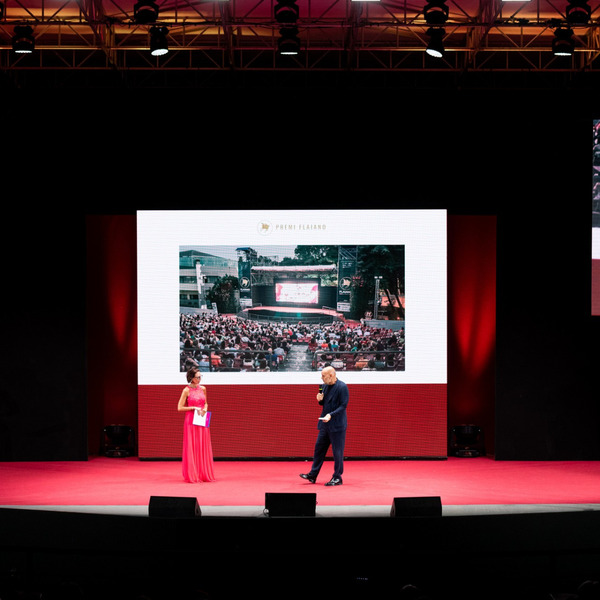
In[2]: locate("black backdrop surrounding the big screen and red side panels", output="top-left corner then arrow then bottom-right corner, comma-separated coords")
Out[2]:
0,86 -> 600,460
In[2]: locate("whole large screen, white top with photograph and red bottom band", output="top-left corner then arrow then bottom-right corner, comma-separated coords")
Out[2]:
137,210 -> 447,460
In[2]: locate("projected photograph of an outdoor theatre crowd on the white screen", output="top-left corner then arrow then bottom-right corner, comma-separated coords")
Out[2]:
179,245 -> 406,373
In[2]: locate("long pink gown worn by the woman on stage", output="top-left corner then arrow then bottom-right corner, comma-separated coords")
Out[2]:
183,387 -> 215,483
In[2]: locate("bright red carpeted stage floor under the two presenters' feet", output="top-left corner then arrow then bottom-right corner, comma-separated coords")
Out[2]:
0,457 -> 600,506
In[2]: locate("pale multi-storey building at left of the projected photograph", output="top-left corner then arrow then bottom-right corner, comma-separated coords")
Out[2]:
179,250 -> 238,308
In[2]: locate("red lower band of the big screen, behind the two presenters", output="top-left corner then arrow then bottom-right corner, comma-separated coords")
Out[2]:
138,384 -> 447,459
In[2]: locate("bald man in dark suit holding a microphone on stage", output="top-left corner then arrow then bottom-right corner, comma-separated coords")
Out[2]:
300,366 -> 349,486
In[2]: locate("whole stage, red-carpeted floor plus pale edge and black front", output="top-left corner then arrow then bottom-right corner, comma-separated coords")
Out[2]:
0,457 -> 600,600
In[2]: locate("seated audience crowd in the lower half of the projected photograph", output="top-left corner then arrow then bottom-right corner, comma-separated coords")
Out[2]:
180,313 -> 405,372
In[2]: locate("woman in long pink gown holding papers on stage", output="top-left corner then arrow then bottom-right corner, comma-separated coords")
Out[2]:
177,368 -> 215,483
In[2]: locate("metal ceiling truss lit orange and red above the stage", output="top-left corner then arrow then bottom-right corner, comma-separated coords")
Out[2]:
0,0 -> 600,73
